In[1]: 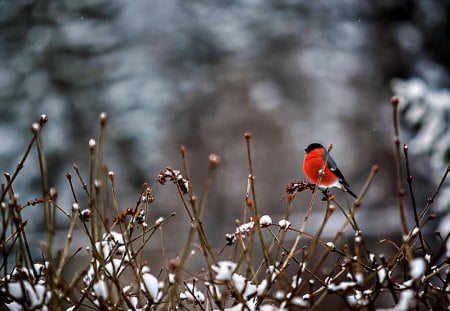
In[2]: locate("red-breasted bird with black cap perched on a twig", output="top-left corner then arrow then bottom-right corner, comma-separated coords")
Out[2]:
303,143 -> 357,198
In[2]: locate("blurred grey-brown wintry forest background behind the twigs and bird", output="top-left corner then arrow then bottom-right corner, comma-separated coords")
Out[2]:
0,0 -> 450,268
